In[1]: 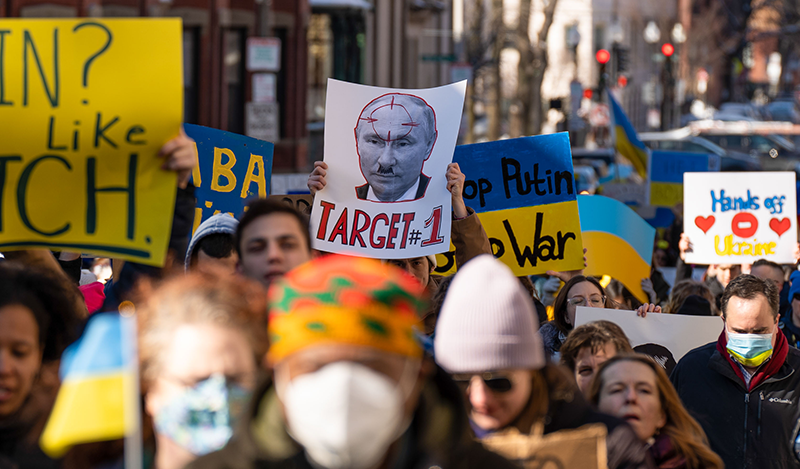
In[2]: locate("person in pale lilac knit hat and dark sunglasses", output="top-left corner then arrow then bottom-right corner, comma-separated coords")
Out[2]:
434,255 -> 652,469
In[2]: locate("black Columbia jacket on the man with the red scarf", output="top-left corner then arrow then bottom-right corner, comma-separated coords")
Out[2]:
670,335 -> 800,469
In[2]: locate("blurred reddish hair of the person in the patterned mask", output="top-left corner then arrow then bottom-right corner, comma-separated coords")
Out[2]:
137,273 -> 269,389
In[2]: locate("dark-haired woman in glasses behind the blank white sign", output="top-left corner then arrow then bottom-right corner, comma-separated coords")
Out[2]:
539,275 -> 615,362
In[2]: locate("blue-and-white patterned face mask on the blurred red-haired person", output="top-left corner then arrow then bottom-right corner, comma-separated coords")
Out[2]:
154,374 -> 252,456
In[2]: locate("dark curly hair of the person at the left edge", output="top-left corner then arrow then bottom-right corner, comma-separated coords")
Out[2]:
0,261 -> 85,362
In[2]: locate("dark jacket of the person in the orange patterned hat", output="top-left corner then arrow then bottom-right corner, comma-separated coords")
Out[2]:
186,368 -> 516,469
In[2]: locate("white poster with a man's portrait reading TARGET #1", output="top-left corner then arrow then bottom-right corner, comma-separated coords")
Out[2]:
311,80 -> 466,259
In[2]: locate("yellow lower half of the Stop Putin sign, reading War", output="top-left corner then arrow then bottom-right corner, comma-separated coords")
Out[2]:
436,200 -> 583,276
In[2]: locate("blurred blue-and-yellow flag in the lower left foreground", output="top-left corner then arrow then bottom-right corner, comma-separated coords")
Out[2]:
39,313 -> 139,458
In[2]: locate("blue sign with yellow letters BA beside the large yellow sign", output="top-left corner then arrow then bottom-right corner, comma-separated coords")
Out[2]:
184,124 -> 274,231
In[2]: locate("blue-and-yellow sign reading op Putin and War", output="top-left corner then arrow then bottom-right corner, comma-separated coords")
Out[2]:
436,132 -> 583,275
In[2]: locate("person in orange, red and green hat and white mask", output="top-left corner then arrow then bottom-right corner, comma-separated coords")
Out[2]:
188,255 -> 514,469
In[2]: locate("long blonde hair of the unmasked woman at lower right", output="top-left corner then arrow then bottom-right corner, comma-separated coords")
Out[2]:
589,353 -> 724,469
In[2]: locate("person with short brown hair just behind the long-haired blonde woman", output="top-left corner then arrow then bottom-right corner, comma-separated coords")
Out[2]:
560,320 -> 633,395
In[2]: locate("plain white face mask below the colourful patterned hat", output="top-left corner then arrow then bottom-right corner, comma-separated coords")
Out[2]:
278,361 -> 410,469
